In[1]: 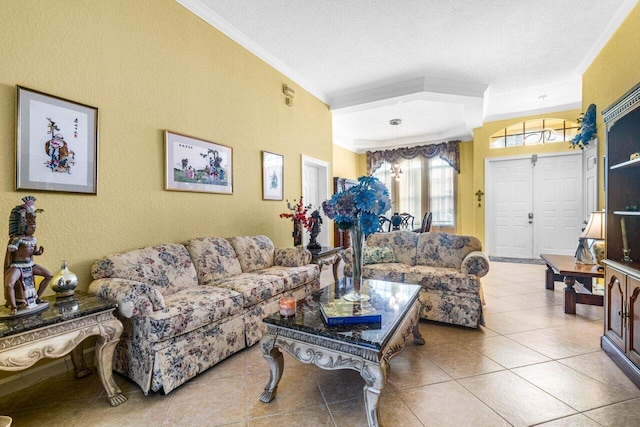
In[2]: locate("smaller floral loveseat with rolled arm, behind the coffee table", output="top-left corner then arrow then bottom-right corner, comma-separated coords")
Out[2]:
344,230 -> 489,328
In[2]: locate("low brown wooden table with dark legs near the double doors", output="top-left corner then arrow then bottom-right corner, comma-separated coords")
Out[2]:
540,254 -> 604,314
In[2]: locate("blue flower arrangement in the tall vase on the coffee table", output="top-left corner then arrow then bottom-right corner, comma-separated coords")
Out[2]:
322,176 -> 391,236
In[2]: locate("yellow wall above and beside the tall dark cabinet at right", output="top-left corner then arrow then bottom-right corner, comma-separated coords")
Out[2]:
582,5 -> 640,208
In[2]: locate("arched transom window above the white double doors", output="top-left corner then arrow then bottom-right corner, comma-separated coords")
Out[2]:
489,118 -> 580,148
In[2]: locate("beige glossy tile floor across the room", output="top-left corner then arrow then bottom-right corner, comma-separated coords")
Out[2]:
0,262 -> 640,427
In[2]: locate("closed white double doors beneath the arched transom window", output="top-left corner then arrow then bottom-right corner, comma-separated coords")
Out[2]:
485,152 -> 584,259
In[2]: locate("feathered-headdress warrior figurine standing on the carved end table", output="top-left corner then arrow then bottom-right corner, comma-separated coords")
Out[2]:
4,196 -> 52,315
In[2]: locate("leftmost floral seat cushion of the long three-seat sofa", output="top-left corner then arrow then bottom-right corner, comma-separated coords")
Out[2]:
145,286 -> 243,342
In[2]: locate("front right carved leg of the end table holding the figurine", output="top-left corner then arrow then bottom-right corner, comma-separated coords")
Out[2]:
96,318 -> 127,406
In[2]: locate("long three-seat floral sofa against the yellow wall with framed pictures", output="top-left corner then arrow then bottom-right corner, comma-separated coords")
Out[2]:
89,236 -> 320,394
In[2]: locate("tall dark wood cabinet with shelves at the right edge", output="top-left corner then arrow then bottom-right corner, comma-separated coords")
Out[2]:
601,84 -> 640,387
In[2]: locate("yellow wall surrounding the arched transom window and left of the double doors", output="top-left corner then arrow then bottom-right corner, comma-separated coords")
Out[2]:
469,110 -> 580,247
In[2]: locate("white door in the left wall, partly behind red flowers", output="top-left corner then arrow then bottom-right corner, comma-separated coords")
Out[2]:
302,155 -> 330,246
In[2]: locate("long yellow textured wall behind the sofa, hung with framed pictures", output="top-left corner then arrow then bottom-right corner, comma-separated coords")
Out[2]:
0,0 -> 333,298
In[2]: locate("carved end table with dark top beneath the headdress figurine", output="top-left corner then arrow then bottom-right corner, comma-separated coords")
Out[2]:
0,292 -> 127,406
